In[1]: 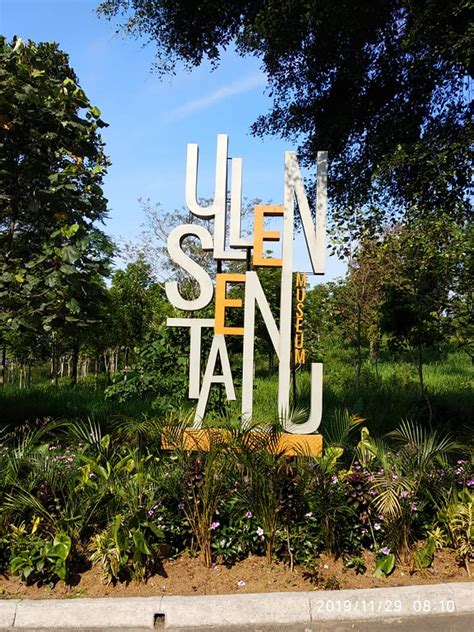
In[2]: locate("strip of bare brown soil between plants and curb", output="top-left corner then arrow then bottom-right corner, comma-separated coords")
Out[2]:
0,549 -> 471,599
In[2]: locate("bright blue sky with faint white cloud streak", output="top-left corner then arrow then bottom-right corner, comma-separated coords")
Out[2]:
0,0 -> 345,280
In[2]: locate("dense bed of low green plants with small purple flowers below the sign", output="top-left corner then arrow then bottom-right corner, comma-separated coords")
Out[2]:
0,411 -> 474,585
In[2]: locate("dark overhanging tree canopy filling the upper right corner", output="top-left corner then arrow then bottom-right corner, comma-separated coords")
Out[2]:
99,0 -> 473,235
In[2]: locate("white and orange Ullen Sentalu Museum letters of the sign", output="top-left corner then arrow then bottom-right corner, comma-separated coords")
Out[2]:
165,134 -> 327,434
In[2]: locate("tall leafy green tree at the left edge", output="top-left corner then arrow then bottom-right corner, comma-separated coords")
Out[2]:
0,38 -> 112,381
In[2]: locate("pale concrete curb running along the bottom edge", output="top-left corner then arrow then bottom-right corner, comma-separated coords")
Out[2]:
0,583 -> 474,631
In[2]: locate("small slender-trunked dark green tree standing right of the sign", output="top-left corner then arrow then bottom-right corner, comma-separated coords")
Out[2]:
379,215 -> 466,421
